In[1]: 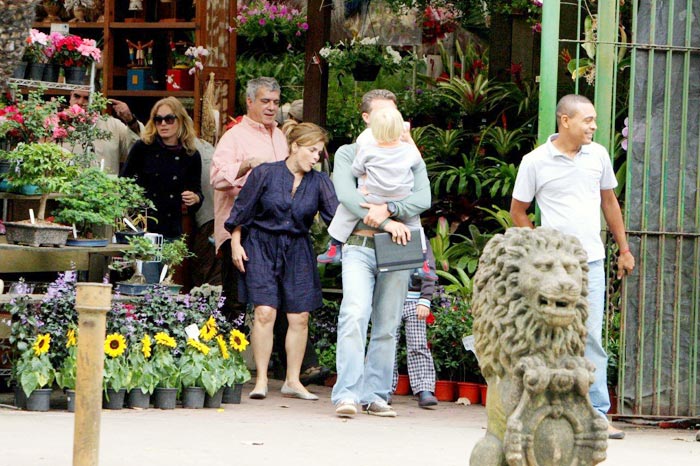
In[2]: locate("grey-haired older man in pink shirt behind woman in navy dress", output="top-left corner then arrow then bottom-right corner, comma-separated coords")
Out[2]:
210,77 -> 288,320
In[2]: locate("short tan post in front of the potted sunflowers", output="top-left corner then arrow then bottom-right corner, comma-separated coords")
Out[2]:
73,283 -> 112,466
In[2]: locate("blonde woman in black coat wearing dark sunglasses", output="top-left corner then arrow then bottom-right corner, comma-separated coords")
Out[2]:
120,97 -> 204,240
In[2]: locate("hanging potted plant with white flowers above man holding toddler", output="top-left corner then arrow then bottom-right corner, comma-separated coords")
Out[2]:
319,37 -> 411,81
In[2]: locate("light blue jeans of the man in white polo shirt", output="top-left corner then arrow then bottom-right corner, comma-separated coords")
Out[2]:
584,259 -> 610,417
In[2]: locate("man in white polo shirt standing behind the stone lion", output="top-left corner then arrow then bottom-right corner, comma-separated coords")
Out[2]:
510,94 -> 634,439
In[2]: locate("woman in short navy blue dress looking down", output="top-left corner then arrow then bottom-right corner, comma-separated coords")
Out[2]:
225,123 -> 338,400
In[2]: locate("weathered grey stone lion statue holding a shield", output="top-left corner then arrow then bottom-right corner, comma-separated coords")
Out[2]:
470,228 -> 607,466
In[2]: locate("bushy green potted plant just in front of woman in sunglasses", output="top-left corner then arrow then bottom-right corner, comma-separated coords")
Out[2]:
55,168 -> 150,246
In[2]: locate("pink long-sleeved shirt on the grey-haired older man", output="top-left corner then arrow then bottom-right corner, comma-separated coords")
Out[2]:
210,116 -> 289,251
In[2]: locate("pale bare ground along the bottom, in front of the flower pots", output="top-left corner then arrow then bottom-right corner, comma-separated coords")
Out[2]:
0,380 -> 700,466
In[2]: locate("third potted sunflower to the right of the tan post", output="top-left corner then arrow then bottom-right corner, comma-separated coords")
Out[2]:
152,332 -> 180,409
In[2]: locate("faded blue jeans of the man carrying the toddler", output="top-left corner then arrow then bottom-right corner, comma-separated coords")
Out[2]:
331,245 -> 410,404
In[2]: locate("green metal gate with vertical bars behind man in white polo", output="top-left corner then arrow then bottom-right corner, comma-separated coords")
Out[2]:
539,0 -> 700,417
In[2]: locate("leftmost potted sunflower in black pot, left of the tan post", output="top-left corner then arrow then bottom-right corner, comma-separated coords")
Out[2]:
13,333 -> 56,411
